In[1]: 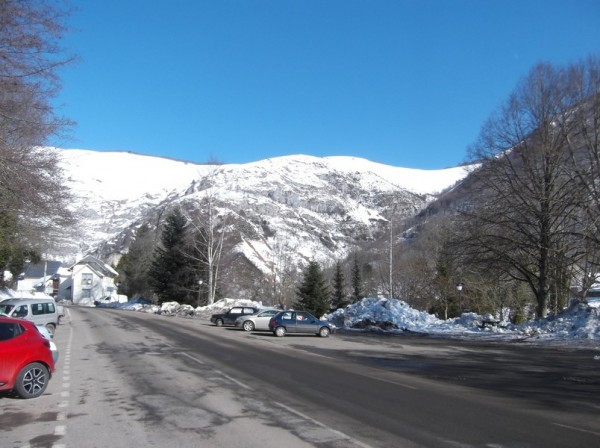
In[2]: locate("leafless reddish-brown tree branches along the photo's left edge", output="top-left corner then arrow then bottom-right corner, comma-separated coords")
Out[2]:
0,0 -> 73,282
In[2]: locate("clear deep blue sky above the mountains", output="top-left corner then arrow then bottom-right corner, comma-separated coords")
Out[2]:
52,0 -> 600,169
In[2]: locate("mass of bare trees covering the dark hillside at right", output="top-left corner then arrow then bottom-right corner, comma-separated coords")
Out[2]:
390,56 -> 600,321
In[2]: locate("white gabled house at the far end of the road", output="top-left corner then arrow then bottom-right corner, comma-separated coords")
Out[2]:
64,255 -> 119,305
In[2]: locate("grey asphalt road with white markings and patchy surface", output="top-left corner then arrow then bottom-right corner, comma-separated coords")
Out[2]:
0,307 -> 600,448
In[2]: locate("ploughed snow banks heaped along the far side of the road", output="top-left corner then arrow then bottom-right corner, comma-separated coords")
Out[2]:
31,288 -> 600,344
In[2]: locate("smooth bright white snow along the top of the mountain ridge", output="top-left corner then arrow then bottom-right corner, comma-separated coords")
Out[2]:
61,149 -> 467,205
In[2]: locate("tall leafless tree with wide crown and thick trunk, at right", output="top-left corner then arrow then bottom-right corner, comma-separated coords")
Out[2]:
456,64 -> 582,317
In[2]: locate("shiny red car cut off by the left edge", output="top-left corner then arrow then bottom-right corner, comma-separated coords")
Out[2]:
0,317 -> 54,398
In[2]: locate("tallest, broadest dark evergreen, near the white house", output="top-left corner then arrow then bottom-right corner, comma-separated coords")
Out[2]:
148,209 -> 192,303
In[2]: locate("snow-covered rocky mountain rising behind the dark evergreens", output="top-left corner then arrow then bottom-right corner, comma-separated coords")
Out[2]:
55,149 -> 468,274
